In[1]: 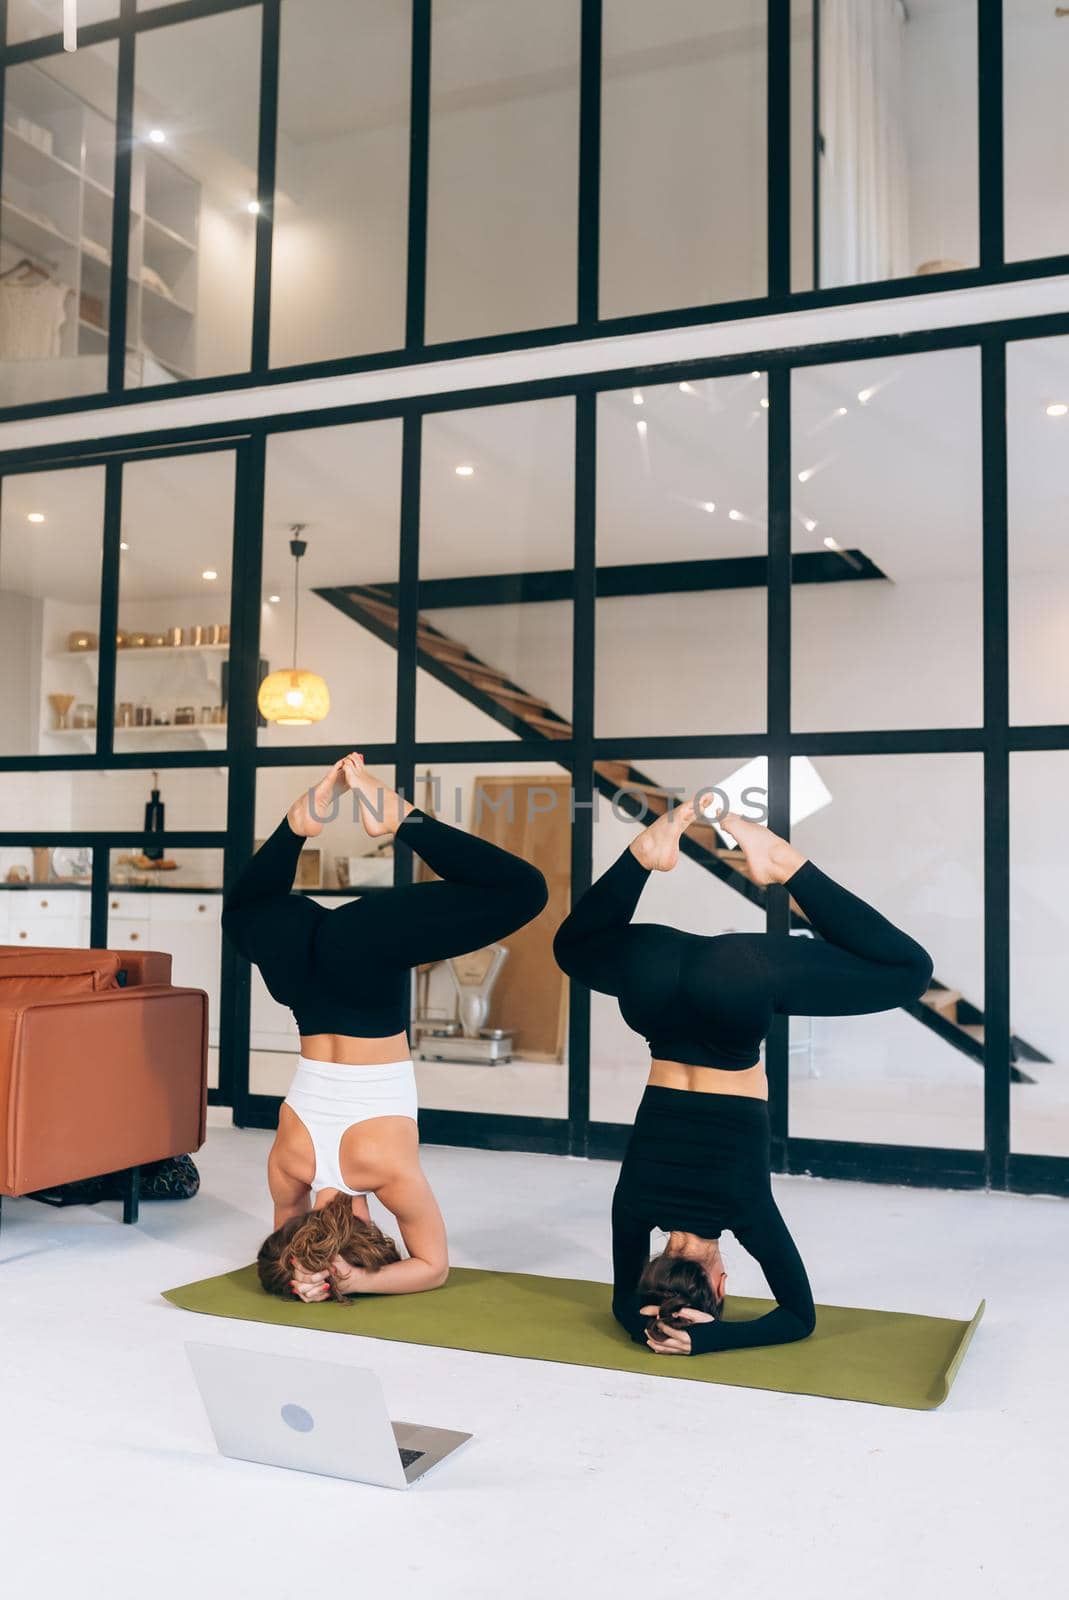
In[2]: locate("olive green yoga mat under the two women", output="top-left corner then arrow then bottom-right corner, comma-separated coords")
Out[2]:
163,1267 -> 984,1411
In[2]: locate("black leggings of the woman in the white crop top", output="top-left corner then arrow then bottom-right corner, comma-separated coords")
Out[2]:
222,810 -> 547,1038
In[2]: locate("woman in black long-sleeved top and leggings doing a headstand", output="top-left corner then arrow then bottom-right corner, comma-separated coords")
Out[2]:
554,802 -> 931,1355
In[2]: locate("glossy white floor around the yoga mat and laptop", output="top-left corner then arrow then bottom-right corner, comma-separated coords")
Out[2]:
0,1114 -> 1069,1600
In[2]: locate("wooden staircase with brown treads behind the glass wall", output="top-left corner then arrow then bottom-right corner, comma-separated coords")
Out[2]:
323,584 -> 1050,1083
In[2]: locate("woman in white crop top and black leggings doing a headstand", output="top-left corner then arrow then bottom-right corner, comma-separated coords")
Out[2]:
222,752 -> 547,1301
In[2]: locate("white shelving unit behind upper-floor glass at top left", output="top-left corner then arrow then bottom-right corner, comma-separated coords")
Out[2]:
0,64 -> 200,398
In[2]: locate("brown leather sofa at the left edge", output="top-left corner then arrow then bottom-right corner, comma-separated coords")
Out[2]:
0,944 -> 208,1222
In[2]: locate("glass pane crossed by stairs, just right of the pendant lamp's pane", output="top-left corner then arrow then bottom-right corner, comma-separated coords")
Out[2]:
416,400 -> 575,742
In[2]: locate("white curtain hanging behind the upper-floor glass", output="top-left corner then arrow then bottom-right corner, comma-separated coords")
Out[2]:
821,0 -> 912,288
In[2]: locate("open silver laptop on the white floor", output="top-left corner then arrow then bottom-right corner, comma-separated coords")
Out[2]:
186,1344 -> 472,1490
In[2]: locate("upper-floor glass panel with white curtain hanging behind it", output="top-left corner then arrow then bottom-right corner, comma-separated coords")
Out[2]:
792,0 -> 979,288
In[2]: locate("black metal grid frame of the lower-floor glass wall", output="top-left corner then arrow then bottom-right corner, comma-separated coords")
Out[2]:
0,312 -> 1069,1194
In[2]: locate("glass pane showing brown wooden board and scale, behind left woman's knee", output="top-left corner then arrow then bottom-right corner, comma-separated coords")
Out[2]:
413,762 -> 571,1117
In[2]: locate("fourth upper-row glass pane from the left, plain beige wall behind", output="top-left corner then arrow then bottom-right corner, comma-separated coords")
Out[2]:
427,0 -> 579,342
